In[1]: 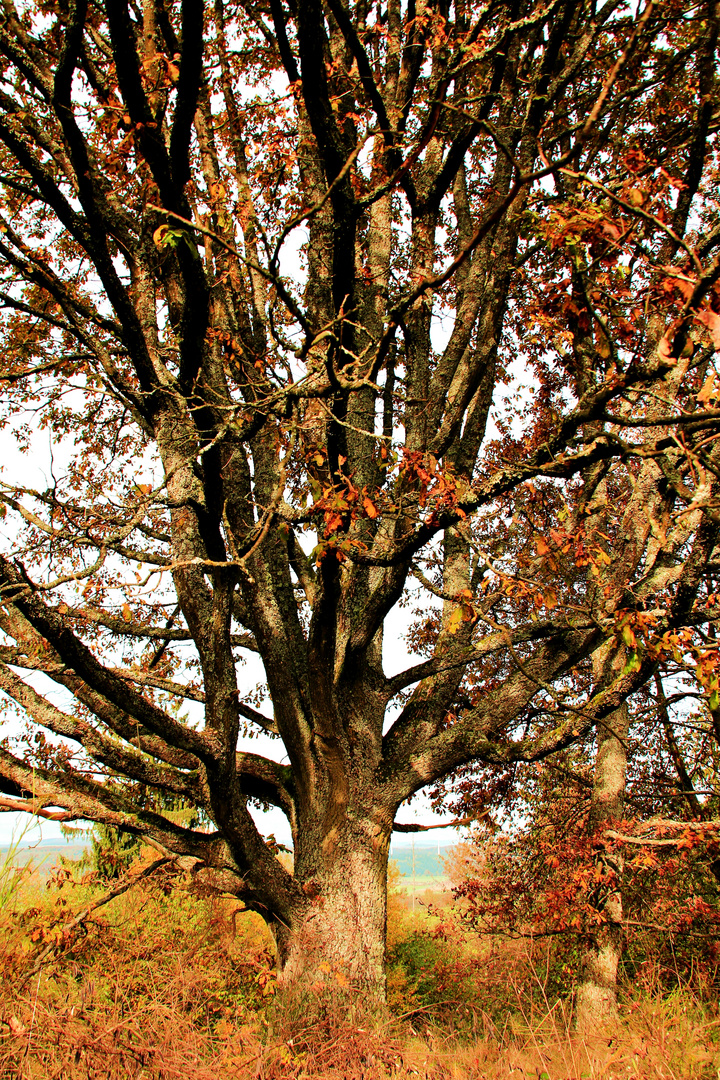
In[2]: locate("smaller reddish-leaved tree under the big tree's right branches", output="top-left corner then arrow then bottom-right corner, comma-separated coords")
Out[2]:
451,682 -> 720,1031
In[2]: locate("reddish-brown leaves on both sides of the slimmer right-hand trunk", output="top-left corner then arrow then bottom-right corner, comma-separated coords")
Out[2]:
451,740 -> 720,993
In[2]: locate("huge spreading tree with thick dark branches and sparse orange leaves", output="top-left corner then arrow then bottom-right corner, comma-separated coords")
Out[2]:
0,0 -> 720,1002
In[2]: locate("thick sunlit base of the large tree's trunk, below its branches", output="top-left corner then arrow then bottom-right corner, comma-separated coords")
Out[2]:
276,829 -> 389,1011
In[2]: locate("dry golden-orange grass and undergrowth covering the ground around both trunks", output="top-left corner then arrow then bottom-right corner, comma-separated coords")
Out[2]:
0,842 -> 720,1080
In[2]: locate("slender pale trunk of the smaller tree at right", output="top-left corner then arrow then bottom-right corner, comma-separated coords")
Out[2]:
575,705 -> 628,1032
